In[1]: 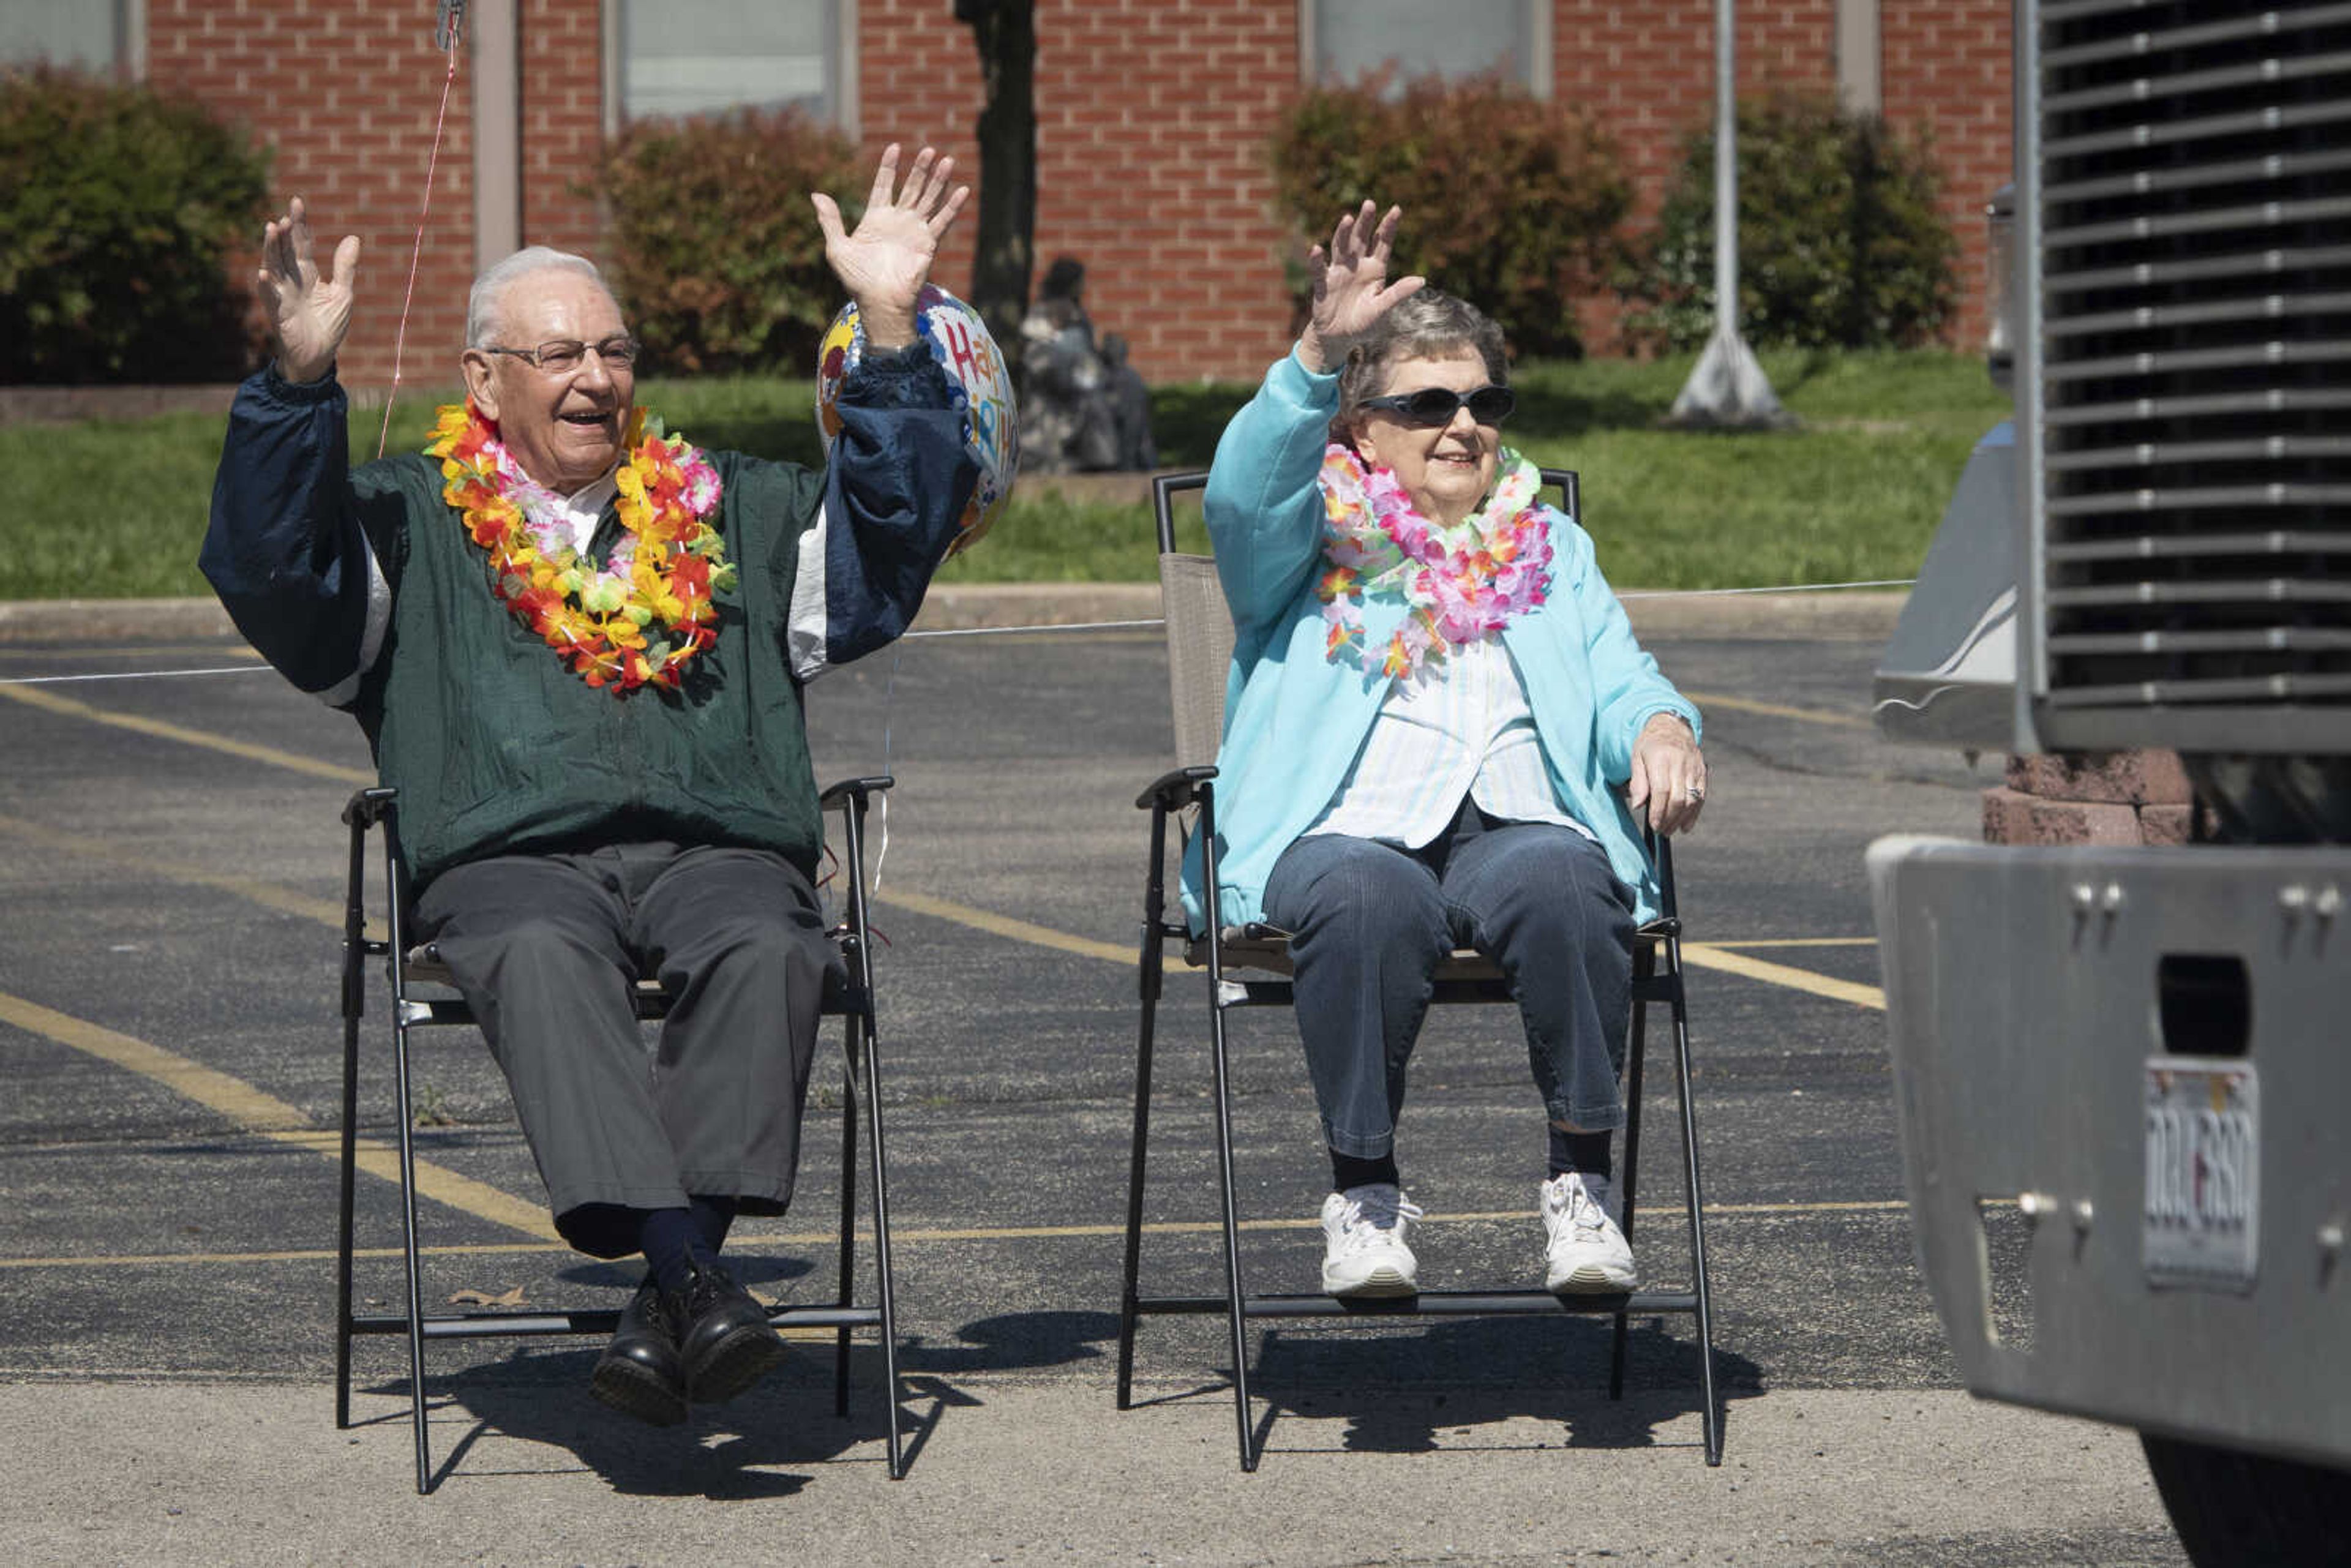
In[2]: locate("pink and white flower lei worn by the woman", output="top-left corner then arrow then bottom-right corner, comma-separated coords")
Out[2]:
1314,445 -> 1551,677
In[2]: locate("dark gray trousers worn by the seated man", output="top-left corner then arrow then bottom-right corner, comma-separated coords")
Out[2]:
416,844 -> 837,1258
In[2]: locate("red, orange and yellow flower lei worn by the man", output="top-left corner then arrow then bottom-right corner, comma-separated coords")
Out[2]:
426,400 -> 736,694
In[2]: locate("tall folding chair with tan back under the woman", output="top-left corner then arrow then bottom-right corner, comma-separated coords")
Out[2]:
1119,468 -> 1723,1472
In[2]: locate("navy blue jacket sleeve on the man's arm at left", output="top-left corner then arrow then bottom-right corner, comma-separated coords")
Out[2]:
198,367 -> 397,708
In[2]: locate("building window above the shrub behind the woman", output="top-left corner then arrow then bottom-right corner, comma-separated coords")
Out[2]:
1300,0 -> 1551,96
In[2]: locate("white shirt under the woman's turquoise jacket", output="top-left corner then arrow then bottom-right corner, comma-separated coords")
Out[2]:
1307,637 -> 1592,849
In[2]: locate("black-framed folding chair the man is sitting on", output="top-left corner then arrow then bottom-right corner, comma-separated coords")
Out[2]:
334,776 -> 905,1493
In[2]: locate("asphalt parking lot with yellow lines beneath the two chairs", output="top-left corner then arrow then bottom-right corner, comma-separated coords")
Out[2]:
0,592 -> 2184,1563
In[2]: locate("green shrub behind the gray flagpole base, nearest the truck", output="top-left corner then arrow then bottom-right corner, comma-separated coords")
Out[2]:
1620,94 -> 1959,348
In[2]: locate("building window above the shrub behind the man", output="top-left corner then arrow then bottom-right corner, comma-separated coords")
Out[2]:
613,0 -> 846,124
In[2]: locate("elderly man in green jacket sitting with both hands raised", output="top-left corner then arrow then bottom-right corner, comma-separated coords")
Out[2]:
202,146 -> 978,1425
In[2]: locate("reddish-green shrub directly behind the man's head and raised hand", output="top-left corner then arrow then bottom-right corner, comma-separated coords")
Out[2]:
593,110 -> 865,376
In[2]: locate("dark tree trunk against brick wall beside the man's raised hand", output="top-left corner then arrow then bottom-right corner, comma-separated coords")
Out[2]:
954,0 -> 1037,355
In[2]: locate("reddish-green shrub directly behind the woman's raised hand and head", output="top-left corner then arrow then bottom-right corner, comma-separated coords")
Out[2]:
1272,75 -> 1632,358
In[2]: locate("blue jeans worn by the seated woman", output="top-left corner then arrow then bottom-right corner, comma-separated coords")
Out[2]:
1265,801 -> 1634,1159
